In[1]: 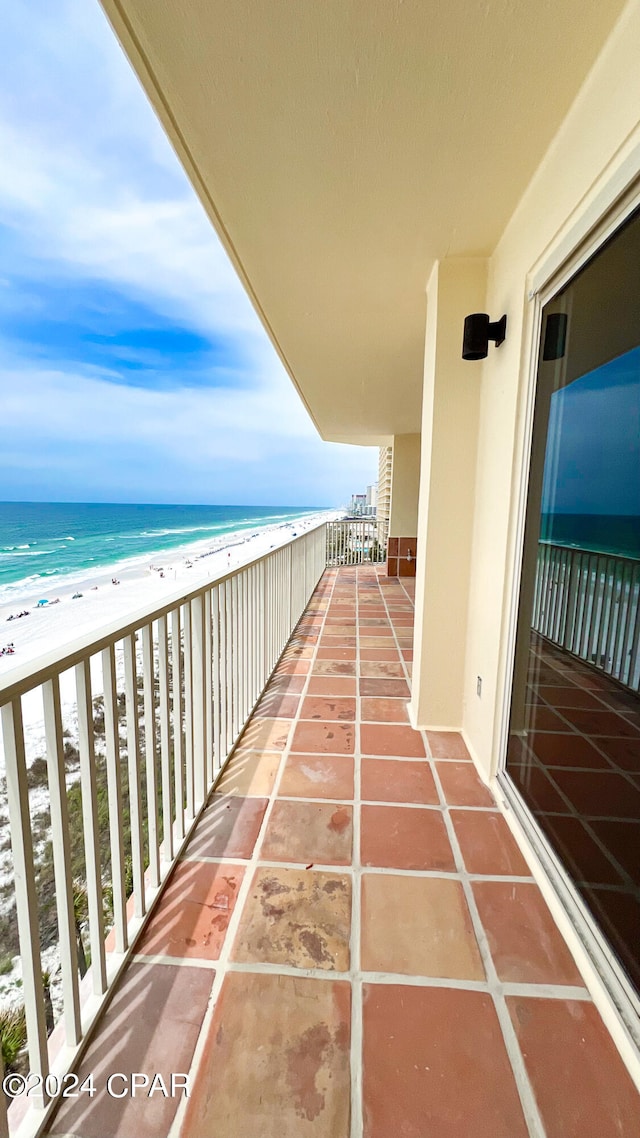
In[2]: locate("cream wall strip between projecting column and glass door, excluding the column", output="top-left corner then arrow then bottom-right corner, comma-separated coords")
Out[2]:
462,2 -> 640,777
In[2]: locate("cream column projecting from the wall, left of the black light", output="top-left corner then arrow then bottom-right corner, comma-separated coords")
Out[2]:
409,257 -> 486,731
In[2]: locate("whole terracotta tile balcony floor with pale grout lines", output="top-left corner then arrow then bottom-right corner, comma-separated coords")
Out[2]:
48,566 -> 640,1138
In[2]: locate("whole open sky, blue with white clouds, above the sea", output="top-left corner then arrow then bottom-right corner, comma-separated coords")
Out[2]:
0,0 -> 378,506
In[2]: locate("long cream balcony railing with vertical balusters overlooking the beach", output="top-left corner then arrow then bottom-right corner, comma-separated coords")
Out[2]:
0,525 -> 326,1136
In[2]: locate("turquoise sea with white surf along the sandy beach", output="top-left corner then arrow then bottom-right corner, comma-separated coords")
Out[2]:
0,502 -> 321,597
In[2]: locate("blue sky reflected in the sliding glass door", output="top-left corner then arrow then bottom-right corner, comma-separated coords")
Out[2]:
542,347 -> 640,516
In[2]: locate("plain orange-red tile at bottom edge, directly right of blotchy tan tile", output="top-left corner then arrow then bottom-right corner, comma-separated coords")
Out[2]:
363,984 -> 526,1138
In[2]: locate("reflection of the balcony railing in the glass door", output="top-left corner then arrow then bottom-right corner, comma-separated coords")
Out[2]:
532,542 -> 640,692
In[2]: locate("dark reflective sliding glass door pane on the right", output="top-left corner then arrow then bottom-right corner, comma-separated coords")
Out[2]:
507,213 -> 640,990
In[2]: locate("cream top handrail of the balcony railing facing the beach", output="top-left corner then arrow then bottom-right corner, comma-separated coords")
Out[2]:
0,521 -> 327,707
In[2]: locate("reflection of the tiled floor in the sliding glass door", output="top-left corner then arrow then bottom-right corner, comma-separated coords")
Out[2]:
508,633 -> 640,988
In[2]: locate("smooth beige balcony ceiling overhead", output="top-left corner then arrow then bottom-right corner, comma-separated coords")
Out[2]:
102,0 -> 623,443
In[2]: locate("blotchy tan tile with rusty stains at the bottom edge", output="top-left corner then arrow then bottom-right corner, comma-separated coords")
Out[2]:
182,973 -> 351,1138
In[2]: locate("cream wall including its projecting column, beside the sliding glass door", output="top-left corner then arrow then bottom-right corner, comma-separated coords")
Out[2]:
410,0 -> 640,778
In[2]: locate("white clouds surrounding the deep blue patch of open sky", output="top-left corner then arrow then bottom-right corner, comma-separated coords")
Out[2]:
0,0 -> 375,503
